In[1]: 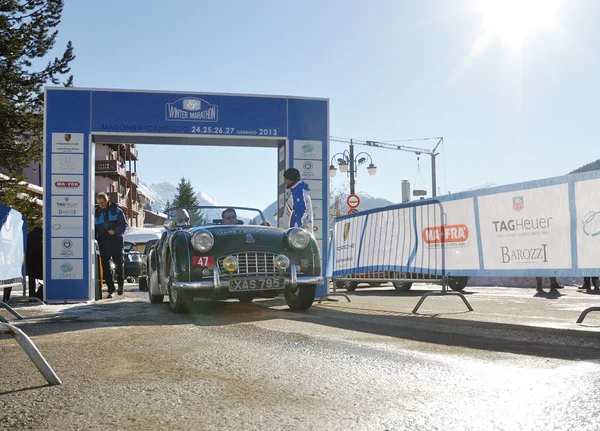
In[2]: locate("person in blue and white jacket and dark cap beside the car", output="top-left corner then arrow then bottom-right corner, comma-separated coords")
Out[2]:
283,168 -> 313,232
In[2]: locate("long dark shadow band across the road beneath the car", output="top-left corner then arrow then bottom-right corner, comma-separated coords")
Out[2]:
3,290 -> 600,360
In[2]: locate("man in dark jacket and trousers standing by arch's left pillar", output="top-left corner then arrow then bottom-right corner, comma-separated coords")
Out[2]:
95,193 -> 127,298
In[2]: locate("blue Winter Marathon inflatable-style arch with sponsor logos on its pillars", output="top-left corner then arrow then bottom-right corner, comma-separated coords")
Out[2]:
44,87 -> 329,302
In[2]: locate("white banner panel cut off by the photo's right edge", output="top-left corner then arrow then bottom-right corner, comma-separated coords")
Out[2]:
575,179 -> 600,268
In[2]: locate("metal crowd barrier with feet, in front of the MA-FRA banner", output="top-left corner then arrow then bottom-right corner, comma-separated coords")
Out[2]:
328,199 -> 473,313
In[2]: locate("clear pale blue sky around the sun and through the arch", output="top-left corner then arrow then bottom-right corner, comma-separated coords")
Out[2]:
52,0 -> 600,208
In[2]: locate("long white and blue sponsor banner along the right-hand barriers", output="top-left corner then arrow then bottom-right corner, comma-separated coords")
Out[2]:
328,171 -> 600,277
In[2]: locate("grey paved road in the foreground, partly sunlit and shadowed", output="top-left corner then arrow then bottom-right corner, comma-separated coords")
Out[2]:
0,285 -> 600,430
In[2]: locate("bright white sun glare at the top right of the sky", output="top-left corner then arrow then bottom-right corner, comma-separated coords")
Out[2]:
477,0 -> 560,44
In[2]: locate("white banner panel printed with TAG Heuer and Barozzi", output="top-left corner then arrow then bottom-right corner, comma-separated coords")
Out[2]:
477,184 -> 572,270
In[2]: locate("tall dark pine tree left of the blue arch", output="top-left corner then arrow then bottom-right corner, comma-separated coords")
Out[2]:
0,0 -> 75,230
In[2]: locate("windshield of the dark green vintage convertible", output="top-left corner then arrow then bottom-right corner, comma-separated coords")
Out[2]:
167,206 -> 266,227
